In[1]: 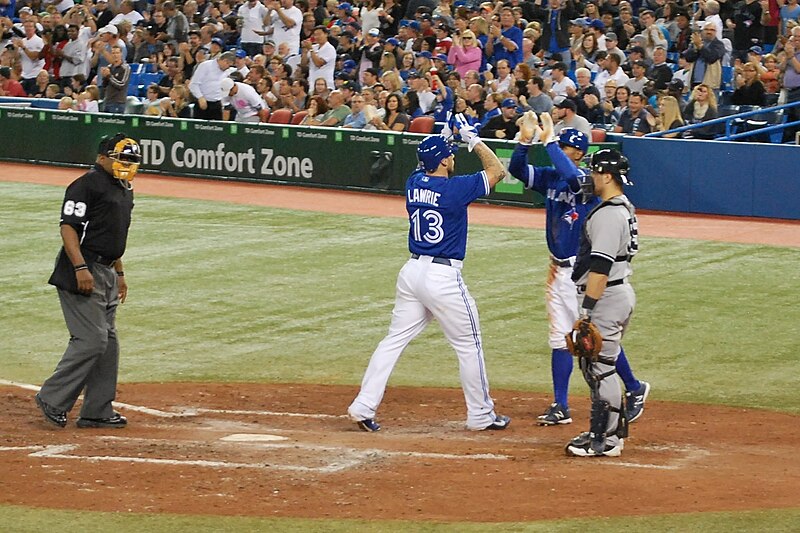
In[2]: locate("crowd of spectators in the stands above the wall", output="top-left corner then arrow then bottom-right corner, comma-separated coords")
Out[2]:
0,0 -> 800,139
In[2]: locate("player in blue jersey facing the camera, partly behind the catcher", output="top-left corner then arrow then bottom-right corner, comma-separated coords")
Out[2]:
509,111 -> 650,426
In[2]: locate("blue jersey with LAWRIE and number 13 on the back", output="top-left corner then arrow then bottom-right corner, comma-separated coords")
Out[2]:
406,166 -> 491,260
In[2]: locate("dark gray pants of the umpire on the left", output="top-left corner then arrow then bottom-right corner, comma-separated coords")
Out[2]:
39,264 -> 119,418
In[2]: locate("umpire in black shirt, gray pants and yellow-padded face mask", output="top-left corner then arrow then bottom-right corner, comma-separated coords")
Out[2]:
36,133 -> 142,428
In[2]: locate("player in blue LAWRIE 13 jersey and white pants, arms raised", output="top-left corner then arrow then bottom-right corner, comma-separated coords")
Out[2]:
347,117 -> 511,431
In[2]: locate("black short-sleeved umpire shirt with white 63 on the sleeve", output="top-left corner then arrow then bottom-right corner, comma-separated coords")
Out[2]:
61,165 -> 133,262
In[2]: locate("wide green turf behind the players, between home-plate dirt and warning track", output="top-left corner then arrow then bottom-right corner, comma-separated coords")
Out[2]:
0,183 -> 800,413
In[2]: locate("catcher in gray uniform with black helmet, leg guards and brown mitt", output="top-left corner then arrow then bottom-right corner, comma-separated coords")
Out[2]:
566,149 -> 639,457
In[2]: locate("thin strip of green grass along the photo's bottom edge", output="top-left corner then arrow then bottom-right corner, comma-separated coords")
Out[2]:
0,506 -> 800,533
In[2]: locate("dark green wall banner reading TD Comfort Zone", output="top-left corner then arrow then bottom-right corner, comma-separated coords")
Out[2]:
0,109 -> 547,205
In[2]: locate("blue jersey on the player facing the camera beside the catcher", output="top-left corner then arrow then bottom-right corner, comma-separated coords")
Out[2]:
508,143 -> 600,259
